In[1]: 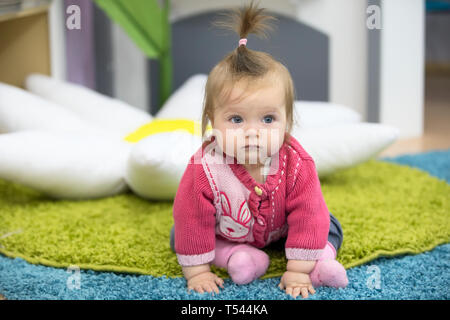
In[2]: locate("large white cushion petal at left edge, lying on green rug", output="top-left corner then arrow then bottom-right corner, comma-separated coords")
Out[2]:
0,131 -> 131,199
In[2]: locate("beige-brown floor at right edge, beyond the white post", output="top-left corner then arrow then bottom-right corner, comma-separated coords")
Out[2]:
379,74 -> 450,157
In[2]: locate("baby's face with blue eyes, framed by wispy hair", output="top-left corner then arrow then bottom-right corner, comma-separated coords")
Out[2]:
211,82 -> 286,165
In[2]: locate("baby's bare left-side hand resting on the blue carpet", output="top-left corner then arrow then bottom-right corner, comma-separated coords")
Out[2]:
183,264 -> 223,293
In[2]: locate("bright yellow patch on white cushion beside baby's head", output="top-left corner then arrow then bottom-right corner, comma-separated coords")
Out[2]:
124,119 -> 212,143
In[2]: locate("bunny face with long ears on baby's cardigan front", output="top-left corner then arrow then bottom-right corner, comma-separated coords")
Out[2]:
219,191 -> 253,239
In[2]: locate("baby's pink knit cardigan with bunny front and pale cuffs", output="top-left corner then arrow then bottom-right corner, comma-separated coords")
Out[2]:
173,136 -> 330,266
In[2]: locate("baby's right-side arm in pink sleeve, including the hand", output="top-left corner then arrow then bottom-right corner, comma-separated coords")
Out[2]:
280,158 -> 330,298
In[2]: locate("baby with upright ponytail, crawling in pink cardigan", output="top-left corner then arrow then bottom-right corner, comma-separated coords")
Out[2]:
171,3 -> 348,298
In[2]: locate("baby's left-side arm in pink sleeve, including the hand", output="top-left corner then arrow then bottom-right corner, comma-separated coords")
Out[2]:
173,156 -> 223,293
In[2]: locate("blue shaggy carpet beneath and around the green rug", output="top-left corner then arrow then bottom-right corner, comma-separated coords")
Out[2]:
0,150 -> 450,300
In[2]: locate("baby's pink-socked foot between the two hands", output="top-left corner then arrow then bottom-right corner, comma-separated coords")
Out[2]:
212,238 -> 269,284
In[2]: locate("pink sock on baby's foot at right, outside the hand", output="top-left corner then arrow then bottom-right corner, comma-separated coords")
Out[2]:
309,242 -> 348,288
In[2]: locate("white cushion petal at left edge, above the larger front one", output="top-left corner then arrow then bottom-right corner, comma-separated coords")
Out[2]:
0,83 -> 104,133
